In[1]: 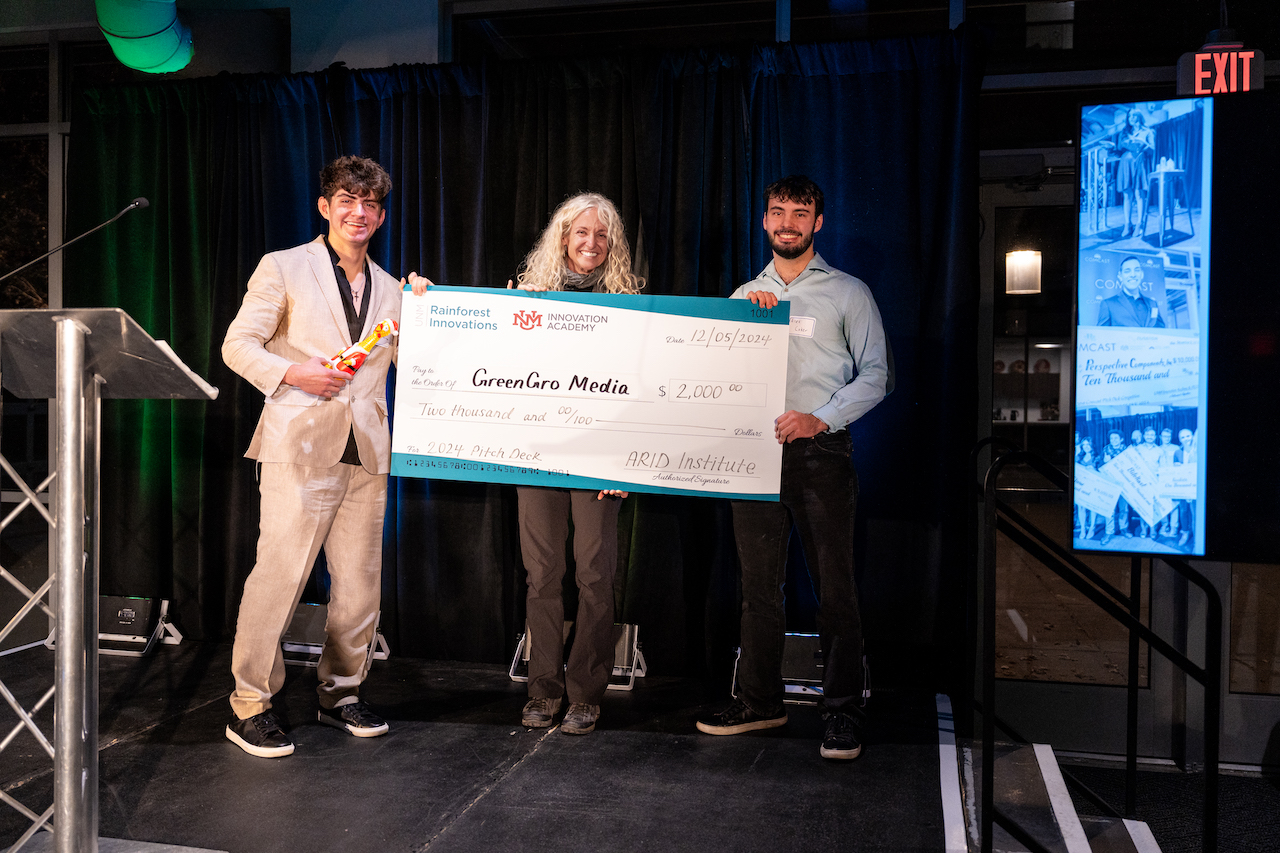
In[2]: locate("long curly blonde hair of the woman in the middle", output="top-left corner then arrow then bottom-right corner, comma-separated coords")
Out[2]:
516,192 -> 644,293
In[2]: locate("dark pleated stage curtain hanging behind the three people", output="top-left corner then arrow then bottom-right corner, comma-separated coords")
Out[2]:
65,33 -> 979,681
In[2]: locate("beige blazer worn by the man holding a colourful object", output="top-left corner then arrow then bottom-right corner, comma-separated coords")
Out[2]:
223,237 -> 401,474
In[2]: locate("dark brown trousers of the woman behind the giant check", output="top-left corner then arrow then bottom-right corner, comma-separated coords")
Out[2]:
516,487 -> 622,704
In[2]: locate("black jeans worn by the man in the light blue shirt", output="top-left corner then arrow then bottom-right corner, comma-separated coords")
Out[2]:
733,432 -> 863,717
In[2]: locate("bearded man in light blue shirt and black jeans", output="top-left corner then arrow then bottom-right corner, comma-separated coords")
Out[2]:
698,175 -> 892,760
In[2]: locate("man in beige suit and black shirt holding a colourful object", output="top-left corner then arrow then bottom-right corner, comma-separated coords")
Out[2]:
223,156 -> 401,758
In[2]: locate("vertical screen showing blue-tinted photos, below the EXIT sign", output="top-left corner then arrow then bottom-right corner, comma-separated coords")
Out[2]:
1073,99 -> 1213,556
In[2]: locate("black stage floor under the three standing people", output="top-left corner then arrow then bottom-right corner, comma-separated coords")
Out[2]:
0,643 -> 943,853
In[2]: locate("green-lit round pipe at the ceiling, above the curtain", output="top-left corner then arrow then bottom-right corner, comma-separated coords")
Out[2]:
95,0 -> 195,74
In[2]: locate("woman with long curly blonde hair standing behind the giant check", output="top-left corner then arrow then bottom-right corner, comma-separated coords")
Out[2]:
508,192 -> 644,734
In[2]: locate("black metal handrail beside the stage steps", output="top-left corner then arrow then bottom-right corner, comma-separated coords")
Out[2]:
970,438 -> 1222,853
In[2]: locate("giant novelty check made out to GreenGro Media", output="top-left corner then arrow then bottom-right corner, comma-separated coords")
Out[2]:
392,287 -> 790,500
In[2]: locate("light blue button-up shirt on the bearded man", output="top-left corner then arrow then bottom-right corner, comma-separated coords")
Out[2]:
732,252 -> 892,430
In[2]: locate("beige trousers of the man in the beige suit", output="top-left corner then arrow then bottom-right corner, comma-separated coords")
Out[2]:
232,462 -> 387,720
